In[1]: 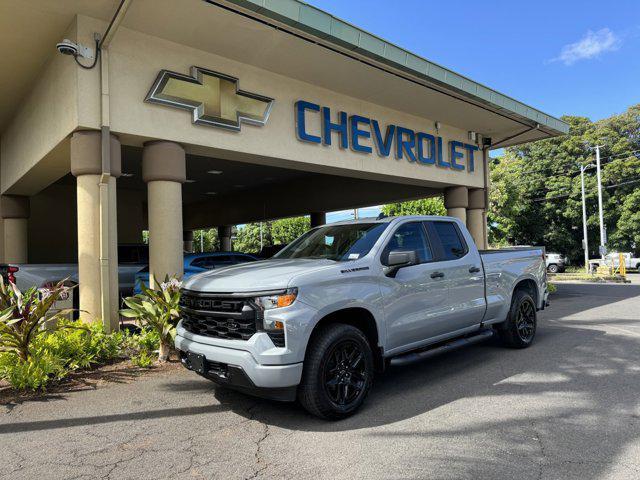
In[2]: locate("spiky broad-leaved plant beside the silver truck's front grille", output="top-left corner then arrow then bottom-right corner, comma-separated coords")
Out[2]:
120,277 -> 182,362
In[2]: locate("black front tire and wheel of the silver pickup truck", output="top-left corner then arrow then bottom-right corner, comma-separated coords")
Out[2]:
298,323 -> 374,420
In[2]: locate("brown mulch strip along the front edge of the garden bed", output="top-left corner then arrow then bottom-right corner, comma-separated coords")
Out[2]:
0,360 -> 184,405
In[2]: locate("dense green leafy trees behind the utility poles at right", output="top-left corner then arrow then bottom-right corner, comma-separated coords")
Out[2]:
489,105 -> 640,261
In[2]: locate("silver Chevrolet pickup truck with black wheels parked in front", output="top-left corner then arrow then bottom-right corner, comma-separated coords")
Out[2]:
175,216 -> 548,419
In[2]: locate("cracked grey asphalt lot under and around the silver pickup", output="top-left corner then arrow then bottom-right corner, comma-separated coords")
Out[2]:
0,284 -> 640,480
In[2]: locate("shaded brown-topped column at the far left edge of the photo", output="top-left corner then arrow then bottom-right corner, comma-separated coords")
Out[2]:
0,195 -> 30,263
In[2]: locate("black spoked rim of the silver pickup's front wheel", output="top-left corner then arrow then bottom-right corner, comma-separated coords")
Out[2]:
324,340 -> 367,407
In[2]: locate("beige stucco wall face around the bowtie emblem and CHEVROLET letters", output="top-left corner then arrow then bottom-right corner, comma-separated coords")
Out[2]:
94,18 -> 483,187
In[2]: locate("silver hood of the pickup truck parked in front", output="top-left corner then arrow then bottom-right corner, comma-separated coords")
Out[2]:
183,258 -> 336,293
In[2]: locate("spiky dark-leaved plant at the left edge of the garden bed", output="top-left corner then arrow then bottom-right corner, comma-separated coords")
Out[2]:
0,277 -> 78,362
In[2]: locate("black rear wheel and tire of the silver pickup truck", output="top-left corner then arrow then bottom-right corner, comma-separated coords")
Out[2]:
498,290 -> 538,348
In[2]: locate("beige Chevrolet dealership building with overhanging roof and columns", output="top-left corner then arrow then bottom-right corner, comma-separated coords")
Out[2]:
0,0 -> 568,328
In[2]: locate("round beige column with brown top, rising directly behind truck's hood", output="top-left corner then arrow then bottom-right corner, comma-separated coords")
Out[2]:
142,141 -> 187,288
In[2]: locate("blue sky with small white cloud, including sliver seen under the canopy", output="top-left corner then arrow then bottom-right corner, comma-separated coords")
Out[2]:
306,0 -> 640,222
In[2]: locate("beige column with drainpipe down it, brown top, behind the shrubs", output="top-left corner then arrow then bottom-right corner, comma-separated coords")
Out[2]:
71,131 -> 122,332
